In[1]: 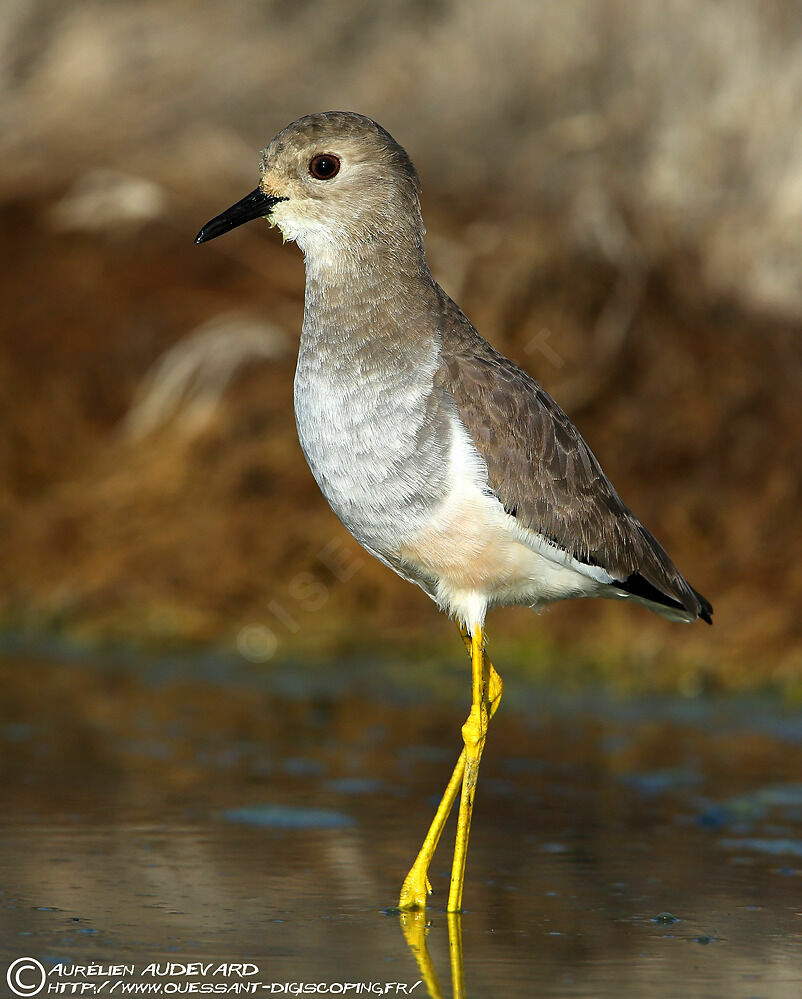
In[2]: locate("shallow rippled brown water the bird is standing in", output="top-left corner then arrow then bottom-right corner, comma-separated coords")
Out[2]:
0,657 -> 802,999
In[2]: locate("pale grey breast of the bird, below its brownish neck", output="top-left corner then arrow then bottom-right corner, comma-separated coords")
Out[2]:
295,282 -> 451,567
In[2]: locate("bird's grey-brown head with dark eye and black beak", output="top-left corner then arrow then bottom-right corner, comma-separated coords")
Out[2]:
195,111 -> 423,252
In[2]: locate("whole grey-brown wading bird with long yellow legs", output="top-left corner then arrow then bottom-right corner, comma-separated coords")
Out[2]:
195,111 -> 712,913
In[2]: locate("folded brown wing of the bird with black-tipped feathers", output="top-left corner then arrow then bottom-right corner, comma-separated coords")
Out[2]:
437,293 -> 712,621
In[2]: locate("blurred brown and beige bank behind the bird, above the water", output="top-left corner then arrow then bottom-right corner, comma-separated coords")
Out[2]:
0,0 -> 802,695
